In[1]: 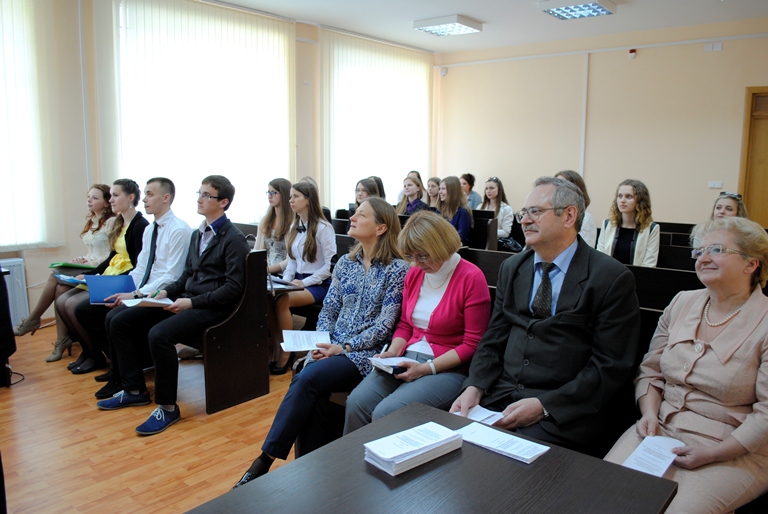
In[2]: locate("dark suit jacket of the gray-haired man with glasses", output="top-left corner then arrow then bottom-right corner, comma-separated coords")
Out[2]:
464,238 -> 640,444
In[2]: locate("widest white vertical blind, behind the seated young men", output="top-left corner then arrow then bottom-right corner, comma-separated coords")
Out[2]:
94,0 -> 295,226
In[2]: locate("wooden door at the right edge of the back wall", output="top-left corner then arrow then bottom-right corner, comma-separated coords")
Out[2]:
740,87 -> 768,227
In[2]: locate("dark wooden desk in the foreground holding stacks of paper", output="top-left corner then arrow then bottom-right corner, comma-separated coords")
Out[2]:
192,404 -> 677,514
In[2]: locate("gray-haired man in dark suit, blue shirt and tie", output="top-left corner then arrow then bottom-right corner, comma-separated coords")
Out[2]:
451,177 -> 640,453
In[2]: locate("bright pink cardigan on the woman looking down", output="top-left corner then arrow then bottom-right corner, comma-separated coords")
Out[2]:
392,259 -> 491,364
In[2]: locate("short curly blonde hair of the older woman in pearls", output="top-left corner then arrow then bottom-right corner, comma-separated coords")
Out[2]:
691,216 -> 768,290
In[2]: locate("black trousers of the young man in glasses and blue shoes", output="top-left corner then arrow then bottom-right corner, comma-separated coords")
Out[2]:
109,307 -> 228,405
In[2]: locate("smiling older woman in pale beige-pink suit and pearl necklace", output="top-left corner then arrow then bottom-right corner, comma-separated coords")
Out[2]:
605,218 -> 768,513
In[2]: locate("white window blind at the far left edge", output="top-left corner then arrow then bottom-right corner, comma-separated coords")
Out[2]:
0,0 -> 64,248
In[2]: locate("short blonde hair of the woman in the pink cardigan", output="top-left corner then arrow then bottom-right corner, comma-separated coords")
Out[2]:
397,209 -> 461,262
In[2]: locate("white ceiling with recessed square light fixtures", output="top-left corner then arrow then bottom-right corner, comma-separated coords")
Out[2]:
224,0 -> 768,52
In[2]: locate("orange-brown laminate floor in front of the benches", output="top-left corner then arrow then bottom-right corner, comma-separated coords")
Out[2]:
0,327 -> 293,513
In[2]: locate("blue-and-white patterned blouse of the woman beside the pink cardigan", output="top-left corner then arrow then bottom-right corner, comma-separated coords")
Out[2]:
317,253 -> 409,376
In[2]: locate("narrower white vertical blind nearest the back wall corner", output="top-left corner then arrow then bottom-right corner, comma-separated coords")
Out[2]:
320,30 -> 434,211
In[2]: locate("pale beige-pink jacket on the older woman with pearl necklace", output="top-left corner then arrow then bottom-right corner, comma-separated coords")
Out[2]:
635,288 -> 768,456
